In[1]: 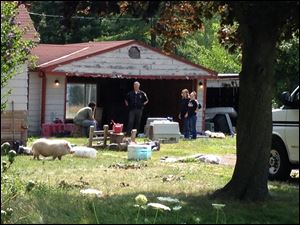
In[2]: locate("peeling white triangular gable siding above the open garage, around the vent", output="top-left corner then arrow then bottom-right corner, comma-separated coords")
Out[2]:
54,45 -> 213,78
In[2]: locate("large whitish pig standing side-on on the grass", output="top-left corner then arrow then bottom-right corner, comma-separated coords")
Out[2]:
32,138 -> 74,160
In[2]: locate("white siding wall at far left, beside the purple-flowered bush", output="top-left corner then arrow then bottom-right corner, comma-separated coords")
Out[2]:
1,64 -> 28,111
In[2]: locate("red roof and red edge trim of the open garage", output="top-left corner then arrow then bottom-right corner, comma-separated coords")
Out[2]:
32,40 -> 217,79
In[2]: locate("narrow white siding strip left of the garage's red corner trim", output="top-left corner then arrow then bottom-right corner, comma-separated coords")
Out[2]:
28,72 -> 42,135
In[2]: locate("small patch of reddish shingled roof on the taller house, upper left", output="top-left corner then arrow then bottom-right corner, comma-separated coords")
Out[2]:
16,4 -> 40,42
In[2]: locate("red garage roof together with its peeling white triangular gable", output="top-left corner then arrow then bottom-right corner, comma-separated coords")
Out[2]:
33,40 -> 217,79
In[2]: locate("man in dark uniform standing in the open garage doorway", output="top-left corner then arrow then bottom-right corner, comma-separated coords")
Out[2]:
125,81 -> 149,135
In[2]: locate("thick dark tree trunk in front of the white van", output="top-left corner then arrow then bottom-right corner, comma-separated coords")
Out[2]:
214,11 -> 276,201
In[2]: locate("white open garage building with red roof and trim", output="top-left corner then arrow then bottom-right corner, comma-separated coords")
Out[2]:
29,40 -> 217,133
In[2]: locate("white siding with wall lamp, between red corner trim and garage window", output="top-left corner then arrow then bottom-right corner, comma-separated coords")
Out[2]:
45,75 -> 65,123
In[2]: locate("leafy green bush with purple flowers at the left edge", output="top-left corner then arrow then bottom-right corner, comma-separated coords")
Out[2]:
1,1 -> 33,112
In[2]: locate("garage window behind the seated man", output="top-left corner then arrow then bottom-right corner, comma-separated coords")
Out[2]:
66,83 -> 97,119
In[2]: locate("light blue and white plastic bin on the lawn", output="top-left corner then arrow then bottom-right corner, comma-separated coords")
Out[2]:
127,144 -> 152,160
